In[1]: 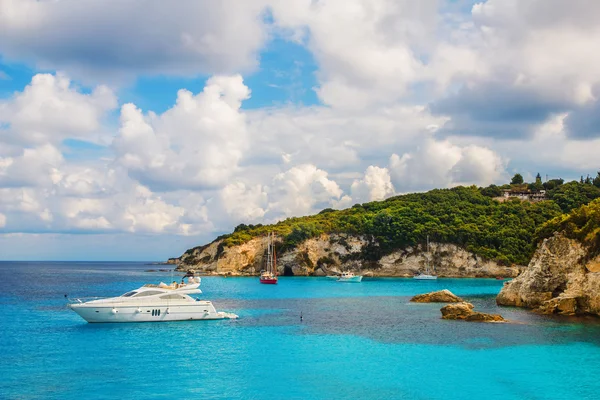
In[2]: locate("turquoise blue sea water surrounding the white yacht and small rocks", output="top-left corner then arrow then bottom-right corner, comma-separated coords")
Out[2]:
0,262 -> 600,399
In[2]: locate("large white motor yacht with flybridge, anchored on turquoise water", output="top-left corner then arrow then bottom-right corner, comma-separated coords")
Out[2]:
68,277 -> 237,322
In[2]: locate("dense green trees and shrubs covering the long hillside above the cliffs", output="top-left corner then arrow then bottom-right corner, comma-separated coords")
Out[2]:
211,173 -> 600,264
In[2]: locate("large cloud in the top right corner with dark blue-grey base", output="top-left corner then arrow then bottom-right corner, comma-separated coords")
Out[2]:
432,0 -> 600,138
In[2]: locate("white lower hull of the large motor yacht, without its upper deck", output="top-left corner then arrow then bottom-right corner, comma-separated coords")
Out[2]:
69,301 -> 232,323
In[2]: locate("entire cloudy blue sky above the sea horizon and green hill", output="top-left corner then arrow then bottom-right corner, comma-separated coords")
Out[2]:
0,0 -> 600,261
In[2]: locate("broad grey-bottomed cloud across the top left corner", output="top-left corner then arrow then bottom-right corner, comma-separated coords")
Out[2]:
0,0 -> 267,82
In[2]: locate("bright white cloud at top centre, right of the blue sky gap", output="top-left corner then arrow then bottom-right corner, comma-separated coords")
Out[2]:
271,0 -> 437,109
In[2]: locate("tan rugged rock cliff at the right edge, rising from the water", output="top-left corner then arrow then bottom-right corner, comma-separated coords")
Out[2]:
496,234 -> 600,315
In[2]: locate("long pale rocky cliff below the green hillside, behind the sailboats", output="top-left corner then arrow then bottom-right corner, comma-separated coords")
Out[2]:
169,234 -> 523,278
